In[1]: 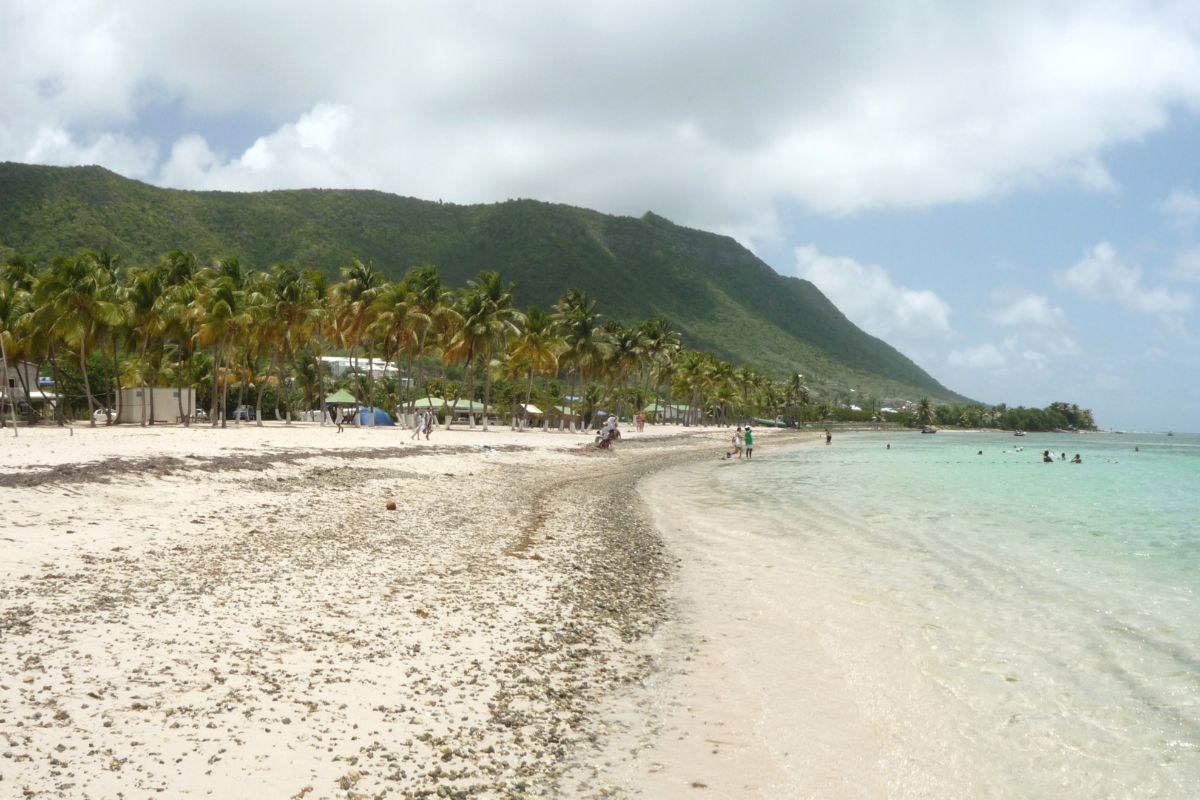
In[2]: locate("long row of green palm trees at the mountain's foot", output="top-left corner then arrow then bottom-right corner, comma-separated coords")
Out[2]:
0,249 -> 1092,429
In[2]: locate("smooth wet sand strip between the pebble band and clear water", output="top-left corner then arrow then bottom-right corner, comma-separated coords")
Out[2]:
604,432 -> 888,800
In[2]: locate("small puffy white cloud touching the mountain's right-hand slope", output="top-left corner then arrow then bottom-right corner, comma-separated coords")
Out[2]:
796,245 -> 950,341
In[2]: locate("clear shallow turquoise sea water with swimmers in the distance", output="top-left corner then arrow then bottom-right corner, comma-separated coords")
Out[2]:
691,432 -> 1200,798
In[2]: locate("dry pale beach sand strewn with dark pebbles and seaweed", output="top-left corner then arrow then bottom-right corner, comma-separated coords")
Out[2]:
0,422 -> 796,798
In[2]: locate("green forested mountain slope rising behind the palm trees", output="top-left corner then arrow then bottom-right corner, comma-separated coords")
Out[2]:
0,163 -> 966,402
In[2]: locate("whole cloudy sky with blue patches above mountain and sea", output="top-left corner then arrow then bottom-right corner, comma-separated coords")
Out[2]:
0,0 -> 1200,431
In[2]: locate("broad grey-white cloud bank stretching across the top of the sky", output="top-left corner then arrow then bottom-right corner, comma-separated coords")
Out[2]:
0,0 -> 1200,241
